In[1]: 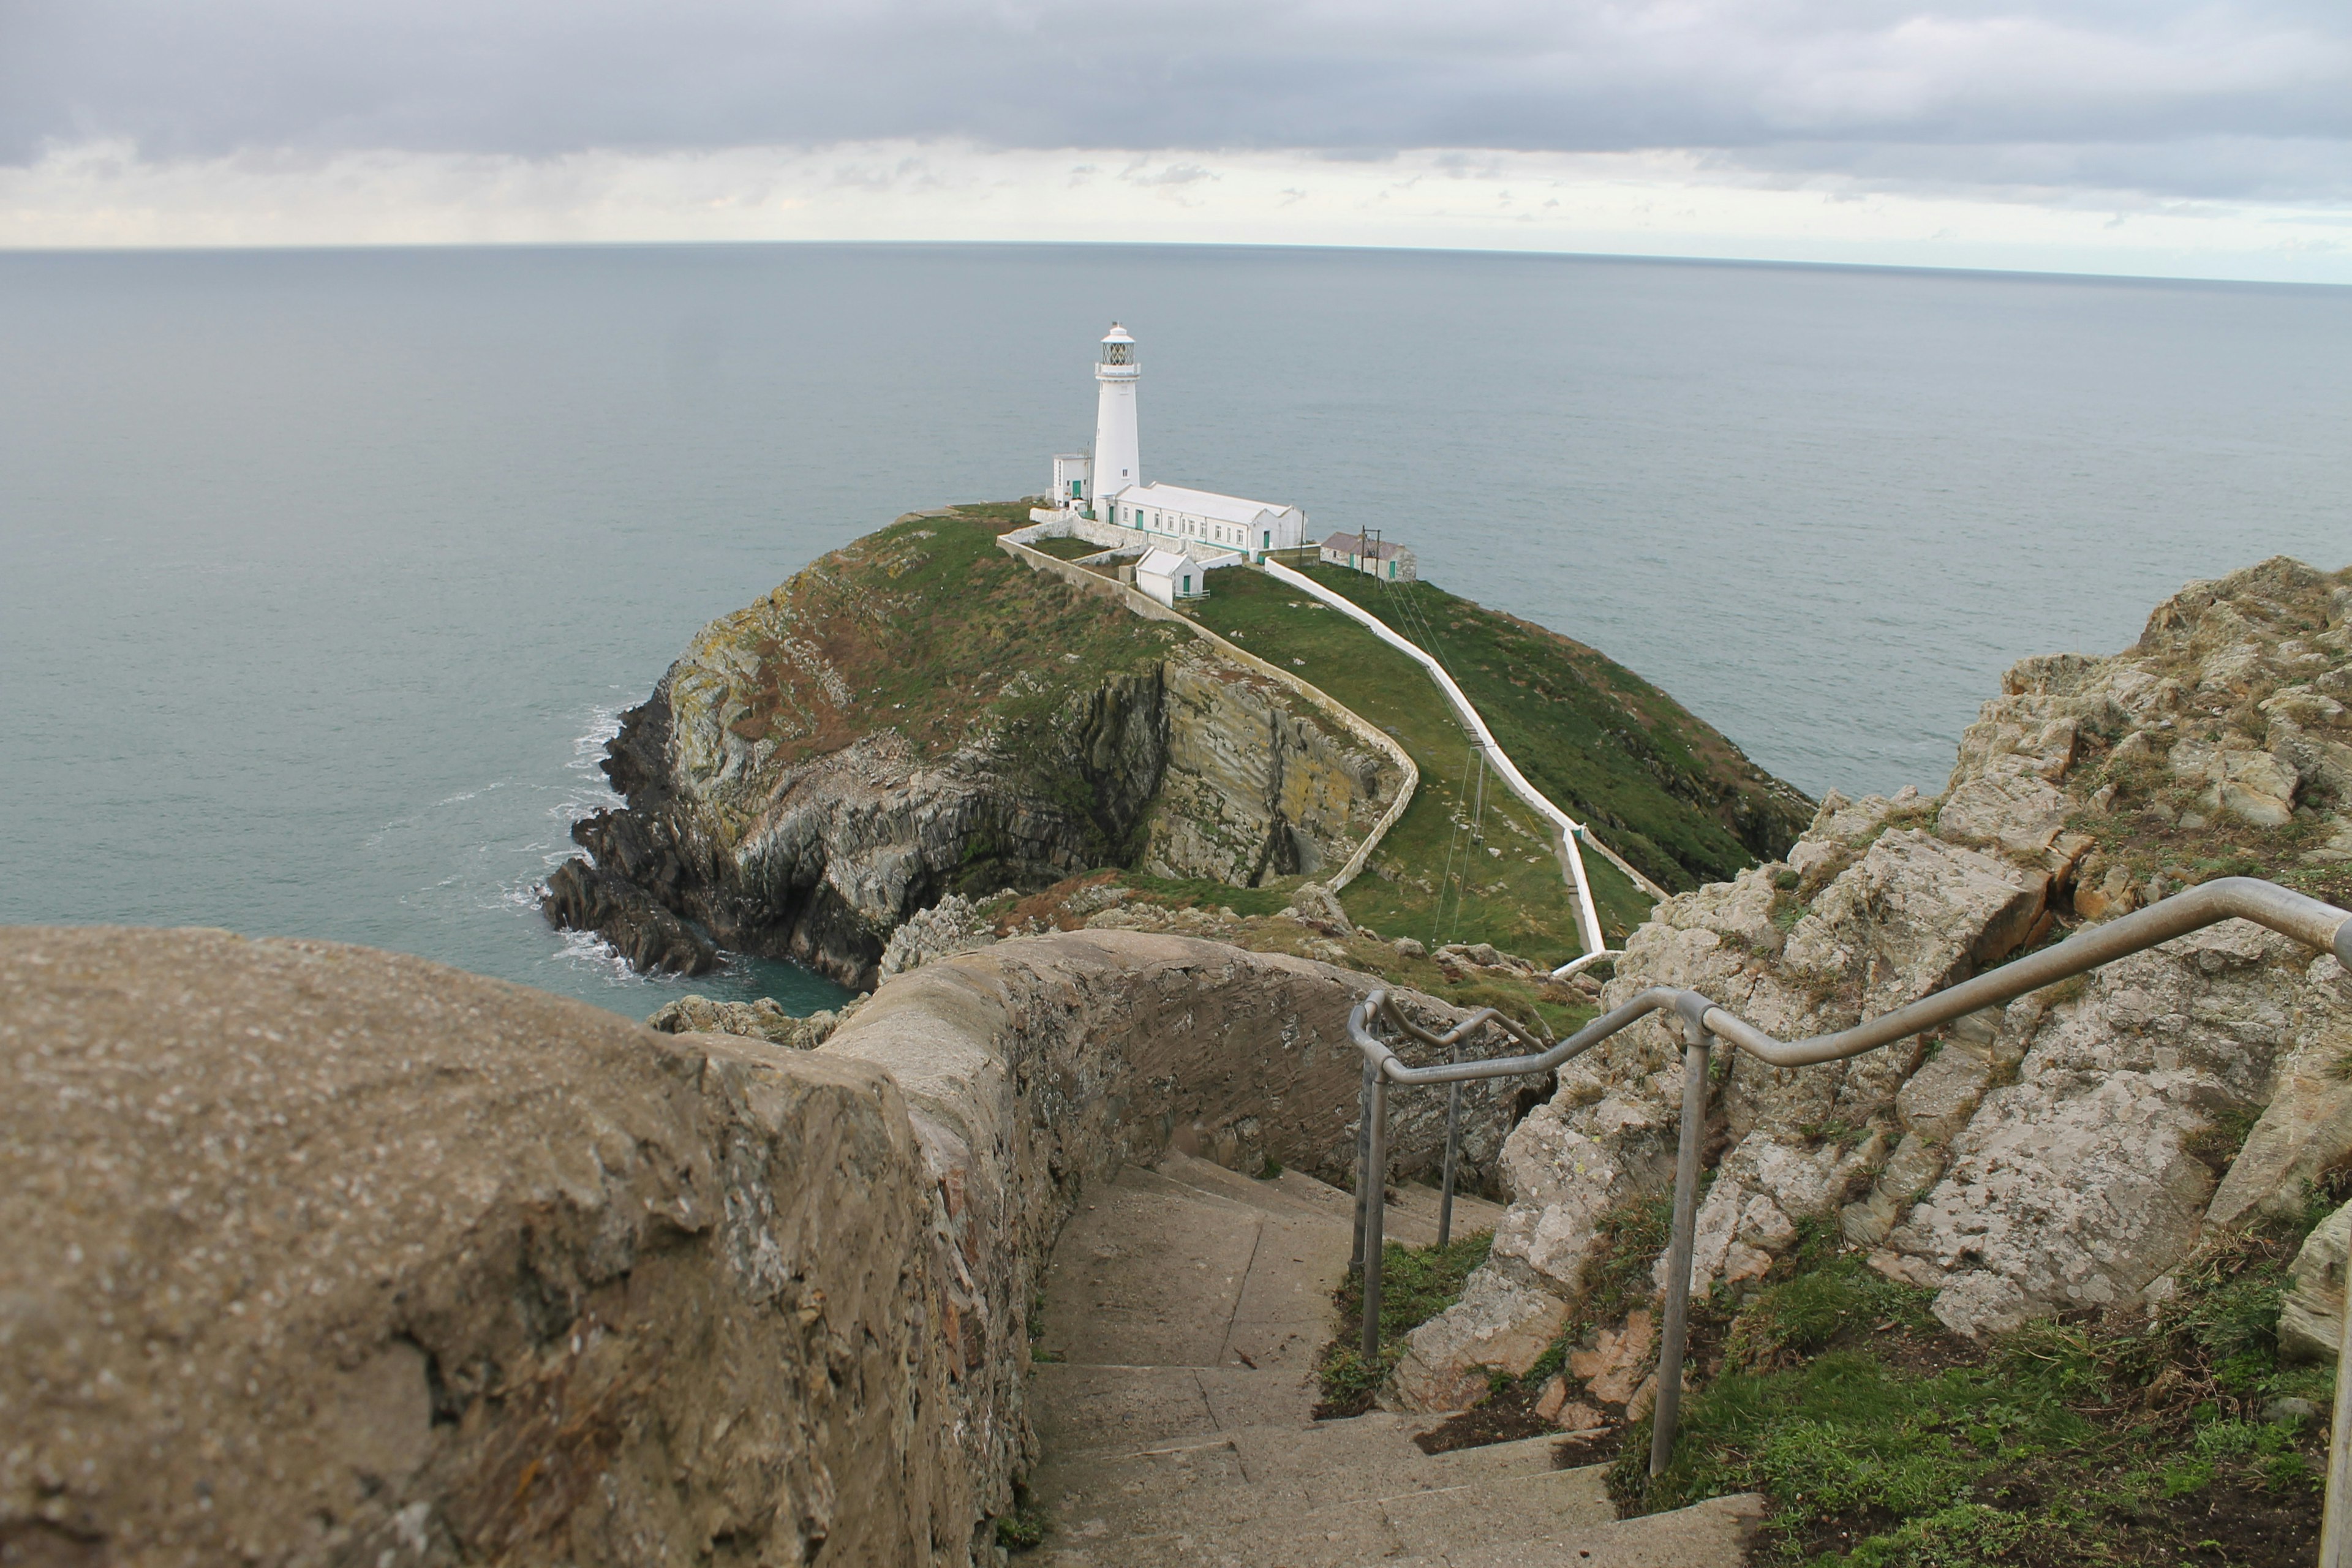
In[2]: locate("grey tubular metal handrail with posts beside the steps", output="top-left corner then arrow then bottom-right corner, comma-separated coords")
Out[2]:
1348,877 -> 2352,1532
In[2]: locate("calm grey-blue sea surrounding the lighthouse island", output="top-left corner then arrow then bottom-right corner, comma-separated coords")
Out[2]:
0,247 -> 2352,1013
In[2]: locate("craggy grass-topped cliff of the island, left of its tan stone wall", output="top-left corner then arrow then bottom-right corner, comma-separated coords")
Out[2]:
546,515 -> 1397,985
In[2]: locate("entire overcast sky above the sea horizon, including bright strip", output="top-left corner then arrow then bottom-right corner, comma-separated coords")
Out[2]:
0,0 -> 2352,282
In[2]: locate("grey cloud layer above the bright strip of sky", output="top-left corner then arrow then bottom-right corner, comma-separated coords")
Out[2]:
0,0 -> 2352,200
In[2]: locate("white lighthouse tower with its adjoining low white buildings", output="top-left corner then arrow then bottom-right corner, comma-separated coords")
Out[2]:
1035,322 -> 1310,597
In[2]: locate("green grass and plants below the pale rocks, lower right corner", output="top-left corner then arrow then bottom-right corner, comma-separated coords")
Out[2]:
1611,1229 -> 2331,1568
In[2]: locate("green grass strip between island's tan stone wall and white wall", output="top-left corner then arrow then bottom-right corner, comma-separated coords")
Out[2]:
1197,569 -> 1651,964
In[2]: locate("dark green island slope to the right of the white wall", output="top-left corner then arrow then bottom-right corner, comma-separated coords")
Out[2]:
1279,567 -> 1814,891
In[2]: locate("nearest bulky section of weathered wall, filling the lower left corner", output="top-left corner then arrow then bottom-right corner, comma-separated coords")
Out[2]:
0,929 -> 955,1566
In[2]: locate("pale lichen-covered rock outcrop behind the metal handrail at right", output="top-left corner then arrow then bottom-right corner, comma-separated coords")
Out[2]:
1400,559 -> 2352,1406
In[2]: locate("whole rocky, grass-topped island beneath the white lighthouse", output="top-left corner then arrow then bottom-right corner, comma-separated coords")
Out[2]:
546,505 -> 1811,987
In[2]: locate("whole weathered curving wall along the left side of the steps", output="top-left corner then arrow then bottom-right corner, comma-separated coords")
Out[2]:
0,929 -> 1507,1566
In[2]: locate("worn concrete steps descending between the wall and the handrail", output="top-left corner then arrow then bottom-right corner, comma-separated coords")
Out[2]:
1016,1154 -> 1755,1568
